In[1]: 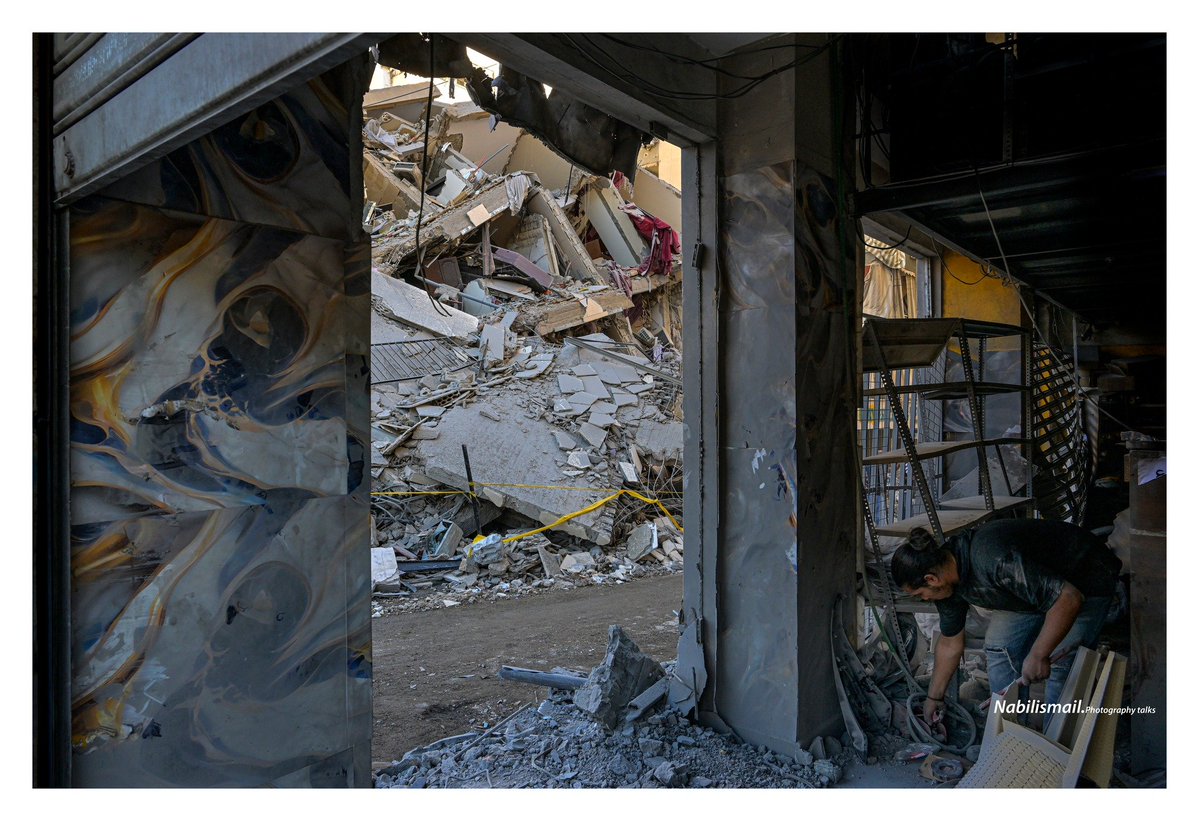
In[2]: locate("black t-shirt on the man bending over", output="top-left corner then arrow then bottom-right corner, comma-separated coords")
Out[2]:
936,519 -> 1120,635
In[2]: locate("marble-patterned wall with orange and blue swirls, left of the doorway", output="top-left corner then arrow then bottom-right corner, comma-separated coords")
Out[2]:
71,62 -> 372,786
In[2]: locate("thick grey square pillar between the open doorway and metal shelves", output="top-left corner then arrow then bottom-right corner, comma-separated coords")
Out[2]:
671,40 -> 861,754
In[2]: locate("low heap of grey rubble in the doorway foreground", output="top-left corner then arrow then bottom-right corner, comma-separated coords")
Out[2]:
375,626 -> 849,789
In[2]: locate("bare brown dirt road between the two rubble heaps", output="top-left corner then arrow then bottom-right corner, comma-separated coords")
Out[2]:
370,574 -> 682,762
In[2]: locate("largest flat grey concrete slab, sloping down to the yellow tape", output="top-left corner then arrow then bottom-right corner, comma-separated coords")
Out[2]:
420,390 -> 611,545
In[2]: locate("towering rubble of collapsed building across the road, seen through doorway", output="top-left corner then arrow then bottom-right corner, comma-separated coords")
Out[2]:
363,92 -> 683,614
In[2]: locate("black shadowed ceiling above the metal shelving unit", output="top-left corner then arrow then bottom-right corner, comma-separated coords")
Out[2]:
855,34 -> 1165,338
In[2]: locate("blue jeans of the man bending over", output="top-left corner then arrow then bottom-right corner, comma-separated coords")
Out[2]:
984,596 -> 1111,704
